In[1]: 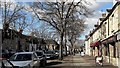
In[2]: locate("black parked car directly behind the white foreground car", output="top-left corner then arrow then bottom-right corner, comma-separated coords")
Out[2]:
35,51 -> 47,66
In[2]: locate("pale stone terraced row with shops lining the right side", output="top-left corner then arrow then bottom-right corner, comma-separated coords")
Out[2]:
85,2 -> 120,67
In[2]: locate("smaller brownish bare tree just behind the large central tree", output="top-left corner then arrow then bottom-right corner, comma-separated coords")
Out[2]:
66,19 -> 85,54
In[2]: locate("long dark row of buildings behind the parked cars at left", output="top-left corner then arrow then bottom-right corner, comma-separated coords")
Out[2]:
0,29 -> 45,51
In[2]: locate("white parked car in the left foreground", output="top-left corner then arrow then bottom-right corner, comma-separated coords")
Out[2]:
5,52 -> 40,68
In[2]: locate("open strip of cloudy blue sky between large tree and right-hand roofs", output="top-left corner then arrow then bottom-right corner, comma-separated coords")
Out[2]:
80,2 -> 113,39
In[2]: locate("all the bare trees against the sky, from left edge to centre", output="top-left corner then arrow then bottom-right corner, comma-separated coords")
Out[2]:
0,0 -> 92,59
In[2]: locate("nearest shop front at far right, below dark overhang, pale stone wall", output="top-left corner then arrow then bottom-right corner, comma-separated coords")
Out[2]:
102,35 -> 117,65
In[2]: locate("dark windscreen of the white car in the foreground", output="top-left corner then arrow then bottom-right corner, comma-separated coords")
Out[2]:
9,54 -> 32,61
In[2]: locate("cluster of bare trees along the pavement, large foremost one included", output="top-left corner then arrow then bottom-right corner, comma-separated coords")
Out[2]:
31,0 -> 92,59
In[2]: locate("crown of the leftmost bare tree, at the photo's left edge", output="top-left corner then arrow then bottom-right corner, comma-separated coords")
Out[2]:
1,2 -> 24,28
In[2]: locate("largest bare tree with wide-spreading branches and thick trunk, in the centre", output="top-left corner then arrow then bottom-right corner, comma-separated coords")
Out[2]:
32,0 -> 91,59
